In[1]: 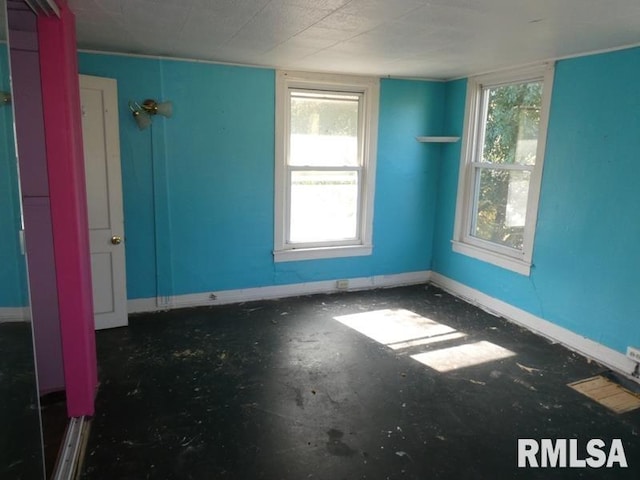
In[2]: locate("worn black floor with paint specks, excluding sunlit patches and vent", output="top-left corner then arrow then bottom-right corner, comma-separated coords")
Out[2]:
82,285 -> 640,480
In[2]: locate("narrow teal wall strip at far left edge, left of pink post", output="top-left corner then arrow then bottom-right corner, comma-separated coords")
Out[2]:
0,43 -> 27,308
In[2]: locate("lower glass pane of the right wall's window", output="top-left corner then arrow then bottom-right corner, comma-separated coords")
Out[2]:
472,168 -> 531,250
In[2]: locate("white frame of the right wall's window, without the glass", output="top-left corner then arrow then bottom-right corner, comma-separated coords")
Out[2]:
451,63 -> 554,276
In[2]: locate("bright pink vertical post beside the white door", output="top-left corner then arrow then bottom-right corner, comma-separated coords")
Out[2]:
38,5 -> 98,417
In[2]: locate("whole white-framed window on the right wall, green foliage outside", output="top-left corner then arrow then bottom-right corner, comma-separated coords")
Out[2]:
453,65 -> 553,275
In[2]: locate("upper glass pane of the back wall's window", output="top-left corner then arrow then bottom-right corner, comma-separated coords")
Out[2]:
289,91 -> 360,167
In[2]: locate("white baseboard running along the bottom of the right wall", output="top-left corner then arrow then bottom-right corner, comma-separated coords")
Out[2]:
430,272 -> 638,381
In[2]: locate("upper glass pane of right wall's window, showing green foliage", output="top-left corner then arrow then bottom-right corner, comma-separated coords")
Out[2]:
482,82 -> 542,165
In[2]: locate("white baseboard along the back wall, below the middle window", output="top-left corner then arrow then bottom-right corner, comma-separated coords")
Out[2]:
127,270 -> 431,313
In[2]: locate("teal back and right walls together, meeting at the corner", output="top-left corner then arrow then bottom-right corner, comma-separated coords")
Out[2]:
70,49 -> 640,351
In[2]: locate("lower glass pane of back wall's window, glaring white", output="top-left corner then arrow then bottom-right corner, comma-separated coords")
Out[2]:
289,171 -> 359,243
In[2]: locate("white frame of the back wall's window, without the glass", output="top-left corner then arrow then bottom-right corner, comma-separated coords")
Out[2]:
273,71 -> 380,262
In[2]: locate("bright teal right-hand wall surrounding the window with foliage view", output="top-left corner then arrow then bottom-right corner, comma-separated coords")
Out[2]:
433,49 -> 640,351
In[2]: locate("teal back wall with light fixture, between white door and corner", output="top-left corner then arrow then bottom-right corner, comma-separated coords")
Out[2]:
79,53 -> 445,299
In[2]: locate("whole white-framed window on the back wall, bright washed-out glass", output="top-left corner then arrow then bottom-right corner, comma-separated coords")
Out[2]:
274,72 -> 379,262
